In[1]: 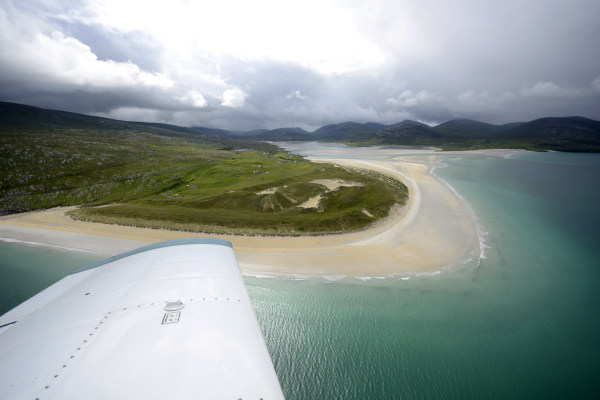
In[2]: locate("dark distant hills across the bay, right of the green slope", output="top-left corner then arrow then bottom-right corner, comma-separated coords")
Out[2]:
206,117 -> 600,152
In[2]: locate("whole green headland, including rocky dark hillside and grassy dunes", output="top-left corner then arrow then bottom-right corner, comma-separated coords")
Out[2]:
0,102 -> 408,235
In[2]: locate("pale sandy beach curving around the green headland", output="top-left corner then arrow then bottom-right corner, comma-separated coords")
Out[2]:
0,156 -> 479,276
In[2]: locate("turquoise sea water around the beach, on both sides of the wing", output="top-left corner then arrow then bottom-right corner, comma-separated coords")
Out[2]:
0,153 -> 600,399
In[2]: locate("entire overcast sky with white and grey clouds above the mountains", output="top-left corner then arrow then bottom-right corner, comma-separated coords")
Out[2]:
0,0 -> 600,130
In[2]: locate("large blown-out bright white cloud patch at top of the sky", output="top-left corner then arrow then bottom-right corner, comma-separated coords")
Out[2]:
62,0 -> 384,73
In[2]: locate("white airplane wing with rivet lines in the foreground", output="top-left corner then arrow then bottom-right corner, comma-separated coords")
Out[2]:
0,239 -> 283,400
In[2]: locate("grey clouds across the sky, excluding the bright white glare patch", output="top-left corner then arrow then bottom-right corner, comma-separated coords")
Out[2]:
0,0 -> 600,130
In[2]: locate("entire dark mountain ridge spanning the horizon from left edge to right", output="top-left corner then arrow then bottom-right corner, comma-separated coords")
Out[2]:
0,102 -> 600,152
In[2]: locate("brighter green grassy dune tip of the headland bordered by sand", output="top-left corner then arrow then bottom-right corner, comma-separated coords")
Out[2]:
71,152 -> 408,235
